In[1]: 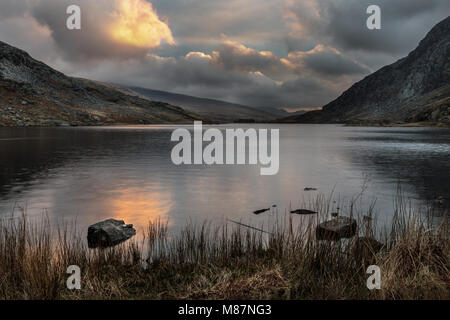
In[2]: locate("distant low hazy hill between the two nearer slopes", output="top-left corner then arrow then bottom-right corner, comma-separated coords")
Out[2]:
127,87 -> 289,122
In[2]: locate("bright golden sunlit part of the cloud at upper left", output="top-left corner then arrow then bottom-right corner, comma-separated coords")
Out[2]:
109,0 -> 175,48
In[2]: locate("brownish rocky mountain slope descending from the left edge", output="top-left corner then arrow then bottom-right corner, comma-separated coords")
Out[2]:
0,41 -> 202,126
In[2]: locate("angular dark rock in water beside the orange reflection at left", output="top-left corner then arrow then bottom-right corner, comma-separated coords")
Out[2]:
88,219 -> 136,248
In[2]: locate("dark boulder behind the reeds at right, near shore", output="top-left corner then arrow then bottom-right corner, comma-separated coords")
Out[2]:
316,217 -> 358,241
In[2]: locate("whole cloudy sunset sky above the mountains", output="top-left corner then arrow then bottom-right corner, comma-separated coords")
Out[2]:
0,0 -> 450,110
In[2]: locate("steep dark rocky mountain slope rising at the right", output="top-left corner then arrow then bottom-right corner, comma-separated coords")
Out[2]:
281,17 -> 450,124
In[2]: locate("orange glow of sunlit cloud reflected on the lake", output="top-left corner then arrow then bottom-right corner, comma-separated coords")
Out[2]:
108,187 -> 173,229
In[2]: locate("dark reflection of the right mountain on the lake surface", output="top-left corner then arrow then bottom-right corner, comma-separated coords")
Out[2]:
347,128 -> 450,203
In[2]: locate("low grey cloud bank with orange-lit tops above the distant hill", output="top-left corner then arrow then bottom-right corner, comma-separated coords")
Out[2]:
65,42 -> 347,108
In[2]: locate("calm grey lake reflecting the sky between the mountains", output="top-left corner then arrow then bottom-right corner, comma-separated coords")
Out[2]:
0,124 -> 450,235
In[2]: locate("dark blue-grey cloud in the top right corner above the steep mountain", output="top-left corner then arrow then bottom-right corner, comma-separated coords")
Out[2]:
287,0 -> 450,55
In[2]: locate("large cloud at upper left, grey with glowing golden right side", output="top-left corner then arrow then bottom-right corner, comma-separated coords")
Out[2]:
32,0 -> 174,61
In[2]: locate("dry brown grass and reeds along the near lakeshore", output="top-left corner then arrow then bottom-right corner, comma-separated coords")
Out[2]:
0,200 -> 450,299
